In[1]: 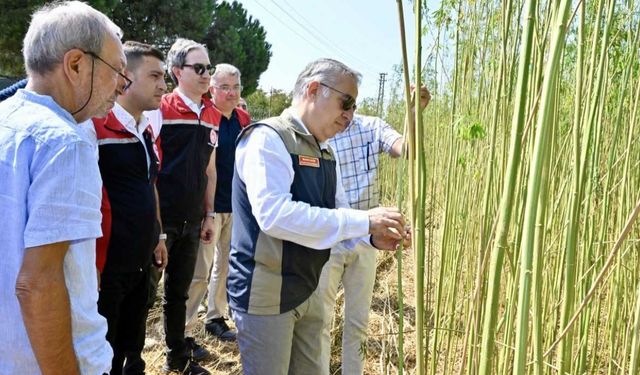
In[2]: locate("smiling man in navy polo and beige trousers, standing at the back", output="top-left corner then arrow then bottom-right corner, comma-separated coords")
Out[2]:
185,64 -> 251,341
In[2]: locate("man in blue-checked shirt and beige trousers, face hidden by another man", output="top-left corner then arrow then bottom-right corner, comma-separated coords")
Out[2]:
317,87 -> 431,375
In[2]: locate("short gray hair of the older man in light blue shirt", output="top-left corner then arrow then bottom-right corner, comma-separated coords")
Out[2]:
22,1 -> 122,75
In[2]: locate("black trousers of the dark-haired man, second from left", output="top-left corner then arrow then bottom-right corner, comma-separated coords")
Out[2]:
98,267 -> 150,375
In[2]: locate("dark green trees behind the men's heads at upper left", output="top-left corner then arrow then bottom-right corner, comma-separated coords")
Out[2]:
0,0 -> 271,95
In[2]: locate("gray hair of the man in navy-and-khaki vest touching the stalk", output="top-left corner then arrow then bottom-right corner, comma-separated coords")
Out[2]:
293,59 -> 362,103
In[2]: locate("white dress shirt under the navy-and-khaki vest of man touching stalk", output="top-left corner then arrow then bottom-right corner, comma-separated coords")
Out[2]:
236,112 -> 369,253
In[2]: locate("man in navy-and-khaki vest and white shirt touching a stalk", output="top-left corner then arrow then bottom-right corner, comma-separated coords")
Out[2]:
227,59 -> 409,375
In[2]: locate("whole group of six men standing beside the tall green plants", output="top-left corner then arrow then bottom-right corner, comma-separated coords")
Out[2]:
0,1 -> 430,375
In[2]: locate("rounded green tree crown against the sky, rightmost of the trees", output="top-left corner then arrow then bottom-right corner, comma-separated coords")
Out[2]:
204,1 -> 271,96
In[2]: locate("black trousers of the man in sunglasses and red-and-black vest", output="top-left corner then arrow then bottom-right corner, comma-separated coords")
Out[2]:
148,220 -> 202,367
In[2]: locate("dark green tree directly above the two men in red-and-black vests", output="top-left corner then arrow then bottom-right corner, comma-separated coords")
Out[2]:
107,0 -> 215,52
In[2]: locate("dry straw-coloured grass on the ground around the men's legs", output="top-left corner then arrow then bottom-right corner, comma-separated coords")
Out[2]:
142,250 -> 415,375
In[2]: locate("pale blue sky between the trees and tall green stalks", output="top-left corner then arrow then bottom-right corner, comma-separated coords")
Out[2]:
239,0 -> 415,101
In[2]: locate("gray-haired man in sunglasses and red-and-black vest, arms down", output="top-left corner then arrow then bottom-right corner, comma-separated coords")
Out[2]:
147,39 -> 220,375
